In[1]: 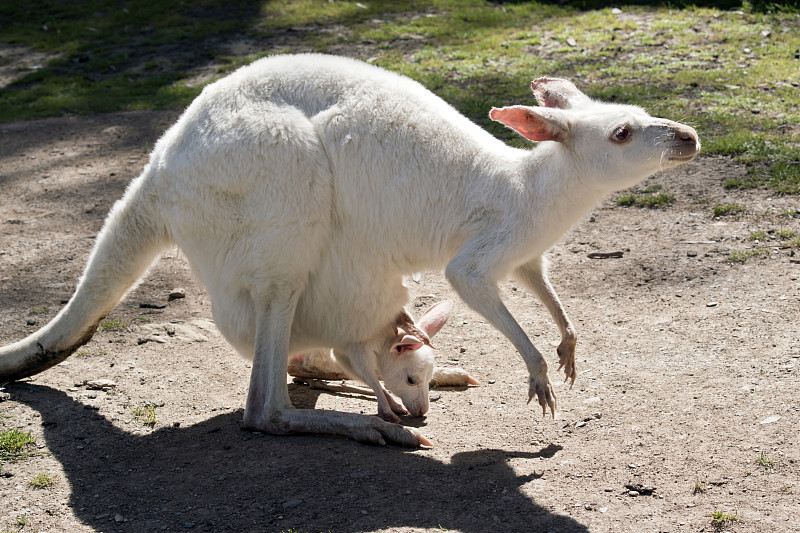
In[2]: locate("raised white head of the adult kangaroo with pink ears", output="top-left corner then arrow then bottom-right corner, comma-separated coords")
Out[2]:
489,78 -> 700,192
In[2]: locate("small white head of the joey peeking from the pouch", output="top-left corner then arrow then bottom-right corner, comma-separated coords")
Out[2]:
378,301 -> 453,416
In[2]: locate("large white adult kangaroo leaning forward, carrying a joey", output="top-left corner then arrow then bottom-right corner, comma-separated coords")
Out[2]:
0,55 -> 700,446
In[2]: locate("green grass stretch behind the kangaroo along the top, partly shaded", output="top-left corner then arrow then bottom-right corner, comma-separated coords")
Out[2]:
0,0 -> 800,194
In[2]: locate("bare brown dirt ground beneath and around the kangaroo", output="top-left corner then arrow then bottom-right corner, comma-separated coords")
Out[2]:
0,97 -> 800,533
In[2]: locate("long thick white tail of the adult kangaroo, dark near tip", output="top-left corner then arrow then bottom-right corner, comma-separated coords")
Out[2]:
0,169 -> 171,378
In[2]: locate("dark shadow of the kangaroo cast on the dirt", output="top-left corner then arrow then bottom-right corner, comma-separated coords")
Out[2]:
7,384 -> 588,533
